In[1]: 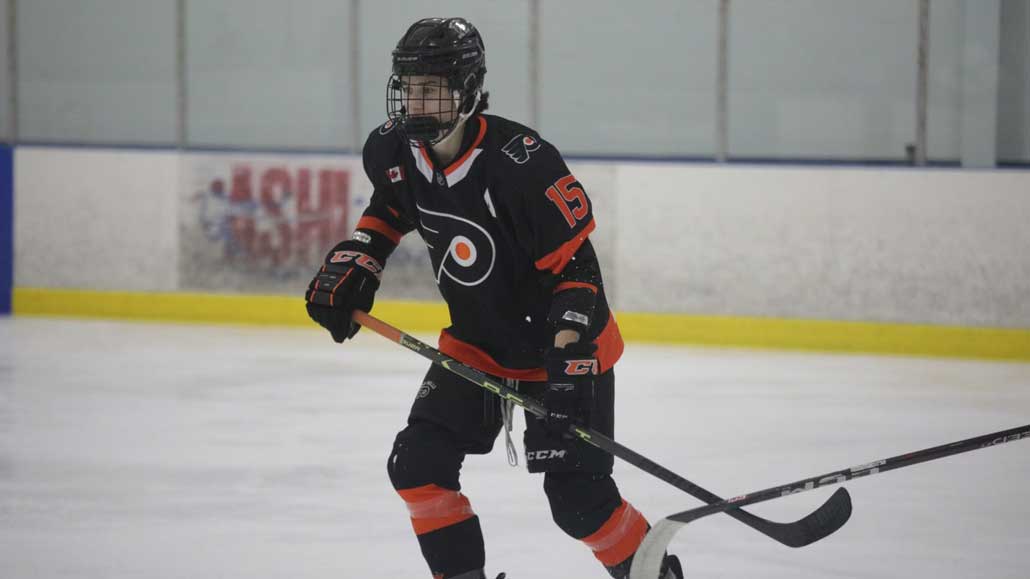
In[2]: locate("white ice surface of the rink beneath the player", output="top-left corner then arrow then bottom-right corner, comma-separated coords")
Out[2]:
0,318 -> 1030,579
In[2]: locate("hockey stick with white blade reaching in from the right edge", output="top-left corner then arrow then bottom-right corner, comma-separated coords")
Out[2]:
629,418 -> 1030,579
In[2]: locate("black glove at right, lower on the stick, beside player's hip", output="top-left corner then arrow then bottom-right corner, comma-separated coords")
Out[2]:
544,342 -> 597,436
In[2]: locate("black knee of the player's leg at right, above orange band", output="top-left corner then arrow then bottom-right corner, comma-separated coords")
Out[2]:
544,473 -> 622,539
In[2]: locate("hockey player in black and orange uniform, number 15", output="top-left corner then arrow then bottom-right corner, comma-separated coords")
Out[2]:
306,19 -> 683,579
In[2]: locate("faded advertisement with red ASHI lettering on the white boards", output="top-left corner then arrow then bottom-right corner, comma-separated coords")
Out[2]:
179,152 -> 439,300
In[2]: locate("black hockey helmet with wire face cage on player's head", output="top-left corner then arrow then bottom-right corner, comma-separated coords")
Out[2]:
386,18 -> 486,144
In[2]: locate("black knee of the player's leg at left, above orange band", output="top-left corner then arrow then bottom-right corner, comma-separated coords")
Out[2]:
386,421 -> 465,490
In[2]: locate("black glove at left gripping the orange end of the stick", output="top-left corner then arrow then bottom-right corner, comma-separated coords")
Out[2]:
304,240 -> 383,343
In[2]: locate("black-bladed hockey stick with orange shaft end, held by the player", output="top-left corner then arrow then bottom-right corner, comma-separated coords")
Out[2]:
353,310 -> 851,543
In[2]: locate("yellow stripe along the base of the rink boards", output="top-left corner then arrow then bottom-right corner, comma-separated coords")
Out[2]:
12,287 -> 1030,361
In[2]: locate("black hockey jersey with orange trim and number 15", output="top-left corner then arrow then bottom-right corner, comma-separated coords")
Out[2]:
354,114 -> 623,380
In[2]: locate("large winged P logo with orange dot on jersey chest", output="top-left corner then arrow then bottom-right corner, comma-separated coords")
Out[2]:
418,206 -> 496,287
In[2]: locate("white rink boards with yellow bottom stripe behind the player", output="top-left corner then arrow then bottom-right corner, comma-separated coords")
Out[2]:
13,147 -> 1030,360
